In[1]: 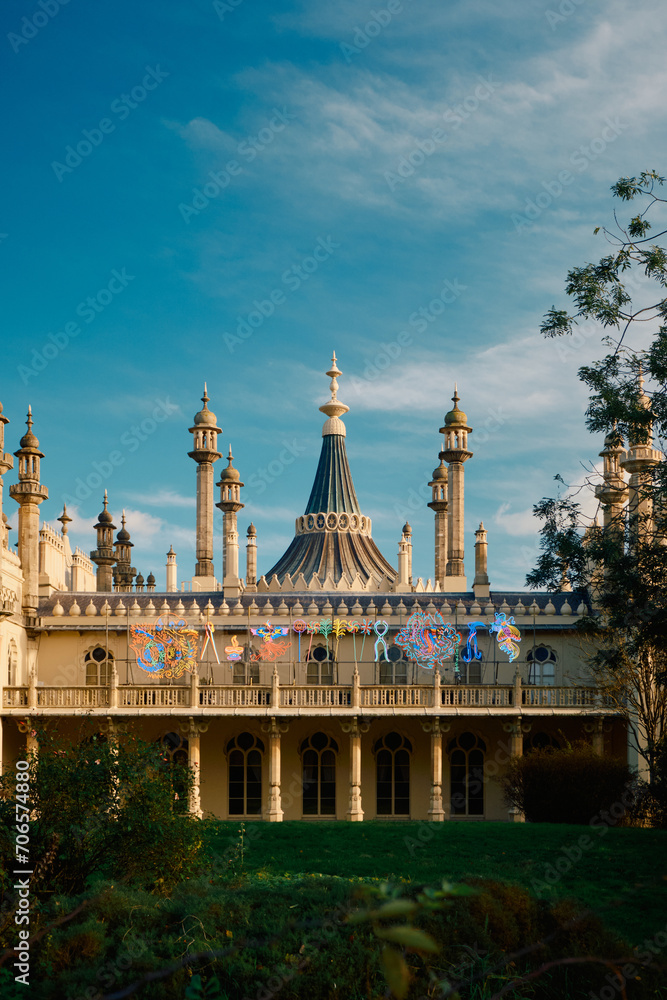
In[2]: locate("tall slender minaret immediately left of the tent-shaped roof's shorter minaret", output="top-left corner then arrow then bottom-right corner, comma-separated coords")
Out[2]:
188,383 -> 222,590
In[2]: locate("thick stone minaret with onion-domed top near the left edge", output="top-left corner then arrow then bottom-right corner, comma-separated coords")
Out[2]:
9,407 -> 49,618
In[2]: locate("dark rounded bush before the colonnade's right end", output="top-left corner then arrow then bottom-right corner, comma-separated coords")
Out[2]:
500,743 -> 634,824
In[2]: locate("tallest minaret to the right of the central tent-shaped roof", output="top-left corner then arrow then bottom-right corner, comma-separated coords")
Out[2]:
440,384 -> 472,593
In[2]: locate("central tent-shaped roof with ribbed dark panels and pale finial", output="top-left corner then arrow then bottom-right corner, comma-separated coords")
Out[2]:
266,354 -> 396,589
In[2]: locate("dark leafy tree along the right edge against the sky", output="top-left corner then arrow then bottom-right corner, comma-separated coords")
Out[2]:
527,170 -> 667,783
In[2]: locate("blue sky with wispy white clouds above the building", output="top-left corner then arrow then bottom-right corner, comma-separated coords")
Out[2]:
0,0 -> 667,589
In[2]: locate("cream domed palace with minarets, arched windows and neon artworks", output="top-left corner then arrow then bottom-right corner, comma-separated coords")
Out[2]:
0,355 -> 648,822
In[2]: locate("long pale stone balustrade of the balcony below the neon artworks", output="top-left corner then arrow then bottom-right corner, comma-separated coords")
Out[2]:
2,677 -> 615,715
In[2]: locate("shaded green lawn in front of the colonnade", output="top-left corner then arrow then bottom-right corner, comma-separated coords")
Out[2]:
207,821 -> 667,945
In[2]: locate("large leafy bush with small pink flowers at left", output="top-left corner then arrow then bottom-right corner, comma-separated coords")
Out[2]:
0,722 -> 203,896
